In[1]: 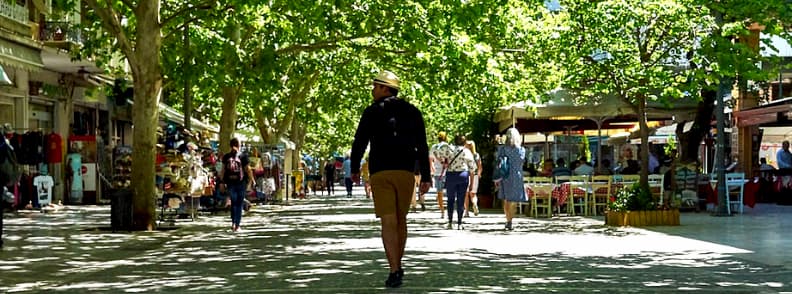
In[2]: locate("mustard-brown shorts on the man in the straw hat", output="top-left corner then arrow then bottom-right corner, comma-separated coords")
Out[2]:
371,170 -> 415,217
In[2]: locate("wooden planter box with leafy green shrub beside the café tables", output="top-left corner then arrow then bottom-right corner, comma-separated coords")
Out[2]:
605,183 -> 679,227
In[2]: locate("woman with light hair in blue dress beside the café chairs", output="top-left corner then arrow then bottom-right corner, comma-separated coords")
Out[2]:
495,128 -> 527,230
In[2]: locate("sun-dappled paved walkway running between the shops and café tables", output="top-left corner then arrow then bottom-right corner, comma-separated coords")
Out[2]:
0,189 -> 792,293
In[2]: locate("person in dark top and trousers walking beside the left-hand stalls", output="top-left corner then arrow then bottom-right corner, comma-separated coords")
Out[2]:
220,138 -> 253,232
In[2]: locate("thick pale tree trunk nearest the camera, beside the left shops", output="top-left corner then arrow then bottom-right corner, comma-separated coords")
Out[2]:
131,0 -> 162,230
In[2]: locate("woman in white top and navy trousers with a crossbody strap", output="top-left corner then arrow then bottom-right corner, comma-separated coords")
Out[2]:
436,135 -> 476,230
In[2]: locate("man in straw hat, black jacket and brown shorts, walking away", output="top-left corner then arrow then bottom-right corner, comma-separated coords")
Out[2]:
352,71 -> 432,288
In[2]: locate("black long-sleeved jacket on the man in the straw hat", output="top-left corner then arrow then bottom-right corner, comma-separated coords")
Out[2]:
351,97 -> 431,182
